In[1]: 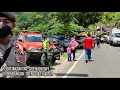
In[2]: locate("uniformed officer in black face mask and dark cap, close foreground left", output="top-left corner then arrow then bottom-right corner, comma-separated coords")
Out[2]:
0,12 -> 26,77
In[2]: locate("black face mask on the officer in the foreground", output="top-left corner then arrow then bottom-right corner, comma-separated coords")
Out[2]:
0,22 -> 12,38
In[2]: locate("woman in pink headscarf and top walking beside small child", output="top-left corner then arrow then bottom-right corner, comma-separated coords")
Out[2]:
70,37 -> 79,61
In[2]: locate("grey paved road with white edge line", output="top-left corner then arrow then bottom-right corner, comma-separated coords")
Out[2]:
57,44 -> 120,78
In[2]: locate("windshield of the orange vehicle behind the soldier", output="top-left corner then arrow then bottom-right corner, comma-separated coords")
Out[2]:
25,35 -> 43,42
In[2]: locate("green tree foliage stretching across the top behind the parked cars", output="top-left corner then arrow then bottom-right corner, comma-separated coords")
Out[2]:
14,12 -> 120,35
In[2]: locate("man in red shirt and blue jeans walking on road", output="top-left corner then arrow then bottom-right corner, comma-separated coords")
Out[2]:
84,33 -> 94,63
